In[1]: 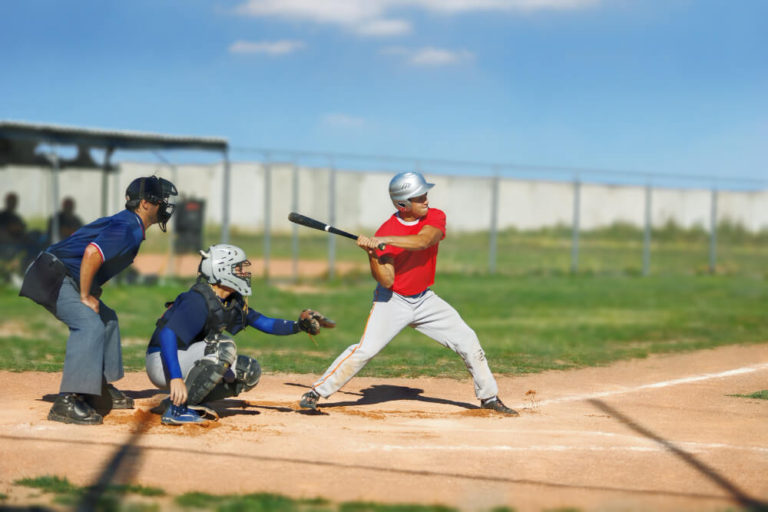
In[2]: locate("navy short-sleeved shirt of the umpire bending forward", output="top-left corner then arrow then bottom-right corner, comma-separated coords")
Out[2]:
46,210 -> 144,286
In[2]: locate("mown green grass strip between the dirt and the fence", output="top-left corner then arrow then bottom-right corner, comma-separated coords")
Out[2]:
0,273 -> 768,378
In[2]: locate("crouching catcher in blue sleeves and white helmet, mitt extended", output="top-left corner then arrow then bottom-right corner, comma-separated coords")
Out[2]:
146,244 -> 336,425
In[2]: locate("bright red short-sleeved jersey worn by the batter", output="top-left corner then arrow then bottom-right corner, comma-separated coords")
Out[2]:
374,208 -> 445,295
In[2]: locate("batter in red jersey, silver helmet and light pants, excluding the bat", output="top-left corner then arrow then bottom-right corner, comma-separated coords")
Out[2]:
299,172 -> 518,416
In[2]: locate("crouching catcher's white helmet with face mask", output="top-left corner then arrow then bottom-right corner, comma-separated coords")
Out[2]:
197,244 -> 251,297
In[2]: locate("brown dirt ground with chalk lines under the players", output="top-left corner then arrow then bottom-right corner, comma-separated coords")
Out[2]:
0,344 -> 768,511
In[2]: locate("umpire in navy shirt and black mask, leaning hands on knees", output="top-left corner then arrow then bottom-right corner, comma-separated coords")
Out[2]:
19,176 -> 178,425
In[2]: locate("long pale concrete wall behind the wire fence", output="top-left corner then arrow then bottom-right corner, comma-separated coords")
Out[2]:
0,162 -> 768,232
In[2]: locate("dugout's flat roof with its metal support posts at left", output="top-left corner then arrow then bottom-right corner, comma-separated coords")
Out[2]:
0,120 -> 234,242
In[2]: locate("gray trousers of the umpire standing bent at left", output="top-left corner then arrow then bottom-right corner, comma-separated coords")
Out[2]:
56,276 -> 123,395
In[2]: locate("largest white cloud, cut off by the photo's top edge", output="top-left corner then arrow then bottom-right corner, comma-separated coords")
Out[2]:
235,0 -> 602,36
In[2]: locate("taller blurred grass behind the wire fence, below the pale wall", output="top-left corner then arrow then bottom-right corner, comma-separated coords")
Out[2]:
135,221 -> 768,278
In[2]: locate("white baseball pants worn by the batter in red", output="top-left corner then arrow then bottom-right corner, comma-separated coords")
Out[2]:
312,286 -> 498,400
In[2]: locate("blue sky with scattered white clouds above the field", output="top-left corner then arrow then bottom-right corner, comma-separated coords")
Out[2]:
0,0 -> 768,188
